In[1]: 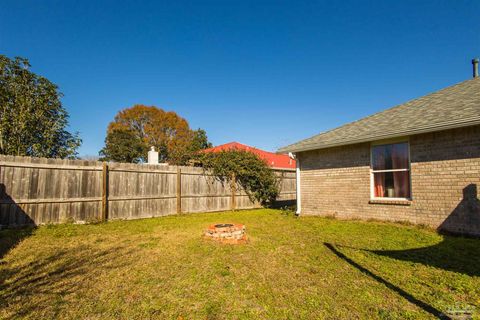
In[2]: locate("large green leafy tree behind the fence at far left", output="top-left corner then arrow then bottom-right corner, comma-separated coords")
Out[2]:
0,55 -> 81,158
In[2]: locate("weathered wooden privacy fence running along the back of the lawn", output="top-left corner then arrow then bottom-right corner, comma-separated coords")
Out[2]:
0,155 -> 295,226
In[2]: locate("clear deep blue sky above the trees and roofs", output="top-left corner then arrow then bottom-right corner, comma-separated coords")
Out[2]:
0,0 -> 480,155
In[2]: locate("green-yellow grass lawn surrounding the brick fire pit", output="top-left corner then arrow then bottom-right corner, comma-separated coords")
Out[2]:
0,210 -> 480,319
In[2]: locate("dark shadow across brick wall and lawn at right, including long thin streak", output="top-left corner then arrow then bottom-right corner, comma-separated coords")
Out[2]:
324,184 -> 480,319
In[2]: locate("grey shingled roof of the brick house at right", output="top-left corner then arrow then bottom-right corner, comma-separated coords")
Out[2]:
278,77 -> 480,153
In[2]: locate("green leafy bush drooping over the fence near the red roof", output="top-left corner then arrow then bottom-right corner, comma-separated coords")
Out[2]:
198,149 -> 279,205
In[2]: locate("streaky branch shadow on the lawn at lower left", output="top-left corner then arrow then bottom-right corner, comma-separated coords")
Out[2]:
0,246 -> 132,319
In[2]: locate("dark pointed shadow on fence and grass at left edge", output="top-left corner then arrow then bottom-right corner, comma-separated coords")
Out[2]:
0,183 -> 35,263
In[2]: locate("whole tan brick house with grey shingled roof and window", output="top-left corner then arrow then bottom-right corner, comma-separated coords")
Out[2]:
279,63 -> 480,236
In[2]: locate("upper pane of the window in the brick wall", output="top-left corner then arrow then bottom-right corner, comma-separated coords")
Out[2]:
372,142 -> 408,170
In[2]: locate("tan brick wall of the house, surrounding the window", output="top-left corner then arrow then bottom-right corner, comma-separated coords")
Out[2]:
298,126 -> 480,235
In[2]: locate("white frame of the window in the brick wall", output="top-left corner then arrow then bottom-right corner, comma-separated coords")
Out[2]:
370,137 -> 413,201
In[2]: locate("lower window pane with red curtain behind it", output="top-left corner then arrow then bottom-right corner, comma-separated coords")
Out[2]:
373,171 -> 410,198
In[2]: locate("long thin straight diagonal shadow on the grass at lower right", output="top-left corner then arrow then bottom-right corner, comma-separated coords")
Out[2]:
324,243 -> 451,319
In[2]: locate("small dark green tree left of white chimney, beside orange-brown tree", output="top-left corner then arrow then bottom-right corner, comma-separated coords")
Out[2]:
100,129 -> 147,163
